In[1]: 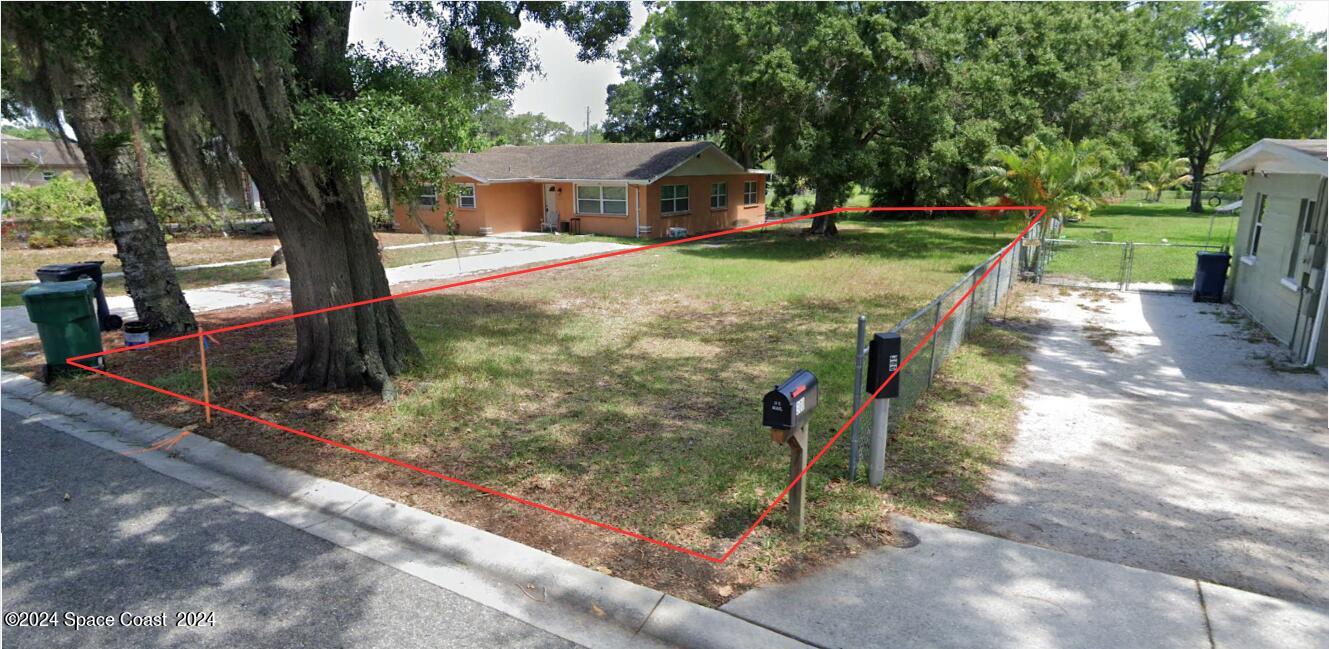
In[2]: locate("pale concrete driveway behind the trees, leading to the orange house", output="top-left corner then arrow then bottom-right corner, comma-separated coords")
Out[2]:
0,237 -> 633,342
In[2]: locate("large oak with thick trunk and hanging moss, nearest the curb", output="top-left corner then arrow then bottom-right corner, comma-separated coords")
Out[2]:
91,1 -> 629,398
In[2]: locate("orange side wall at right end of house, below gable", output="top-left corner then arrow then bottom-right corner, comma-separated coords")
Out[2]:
642,174 -> 766,237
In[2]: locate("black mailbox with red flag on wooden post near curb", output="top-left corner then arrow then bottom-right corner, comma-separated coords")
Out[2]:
762,370 -> 820,535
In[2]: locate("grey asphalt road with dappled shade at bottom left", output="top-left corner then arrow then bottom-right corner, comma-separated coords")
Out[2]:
0,412 -> 577,648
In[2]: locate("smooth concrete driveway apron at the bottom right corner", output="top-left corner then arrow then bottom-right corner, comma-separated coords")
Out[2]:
722,519 -> 1329,649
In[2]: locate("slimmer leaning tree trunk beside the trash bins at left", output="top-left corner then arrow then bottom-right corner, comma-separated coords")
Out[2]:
61,60 -> 197,336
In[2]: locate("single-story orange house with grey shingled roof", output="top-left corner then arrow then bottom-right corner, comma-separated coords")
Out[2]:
393,142 -> 768,237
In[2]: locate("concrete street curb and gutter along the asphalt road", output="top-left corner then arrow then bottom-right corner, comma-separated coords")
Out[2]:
0,371 -> 809,649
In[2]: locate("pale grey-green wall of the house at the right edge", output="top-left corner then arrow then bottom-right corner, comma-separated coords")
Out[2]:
1232,173 -> 1325,363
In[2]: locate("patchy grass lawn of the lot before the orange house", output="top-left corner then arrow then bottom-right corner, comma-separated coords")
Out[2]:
272,221 -> 1019,549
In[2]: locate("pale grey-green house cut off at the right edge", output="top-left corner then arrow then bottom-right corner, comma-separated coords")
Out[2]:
1220,140 -> 1329,368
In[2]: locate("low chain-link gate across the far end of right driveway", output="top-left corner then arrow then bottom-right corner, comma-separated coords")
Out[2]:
1037,239 -> 1221,293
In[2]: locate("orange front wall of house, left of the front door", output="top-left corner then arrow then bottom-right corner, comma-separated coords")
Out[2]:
392,177 -> 544,235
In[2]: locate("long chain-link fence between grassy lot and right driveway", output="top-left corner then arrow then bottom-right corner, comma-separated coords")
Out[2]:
849,239 -> 1030,480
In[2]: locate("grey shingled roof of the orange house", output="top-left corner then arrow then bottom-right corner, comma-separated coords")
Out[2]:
452,142 -> 746,184
